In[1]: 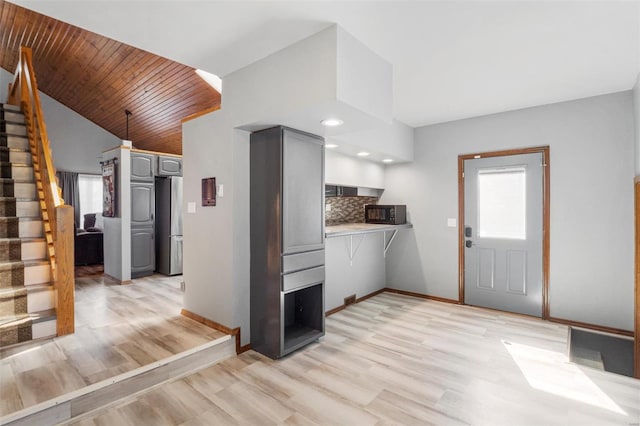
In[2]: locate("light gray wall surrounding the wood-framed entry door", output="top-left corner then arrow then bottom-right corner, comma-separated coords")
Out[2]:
382,92 -> 634,330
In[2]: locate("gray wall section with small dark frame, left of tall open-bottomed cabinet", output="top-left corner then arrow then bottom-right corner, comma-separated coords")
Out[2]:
183,110 -> 251,344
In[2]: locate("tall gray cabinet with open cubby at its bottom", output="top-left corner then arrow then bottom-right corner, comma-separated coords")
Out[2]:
250,127 -> 325,358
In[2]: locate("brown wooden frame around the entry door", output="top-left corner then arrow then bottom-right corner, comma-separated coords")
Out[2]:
458,145 -> 552,319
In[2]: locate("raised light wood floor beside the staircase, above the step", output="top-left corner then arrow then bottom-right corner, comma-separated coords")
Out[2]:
0,275 -> 223,416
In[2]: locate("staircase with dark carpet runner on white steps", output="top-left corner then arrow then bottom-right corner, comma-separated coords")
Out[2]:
0,104 -> 56,348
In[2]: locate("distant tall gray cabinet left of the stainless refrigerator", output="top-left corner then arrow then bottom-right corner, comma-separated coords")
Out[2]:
131,152 -> 157,278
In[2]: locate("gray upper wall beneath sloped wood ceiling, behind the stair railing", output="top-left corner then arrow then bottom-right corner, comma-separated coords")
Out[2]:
0,69 -> 120,174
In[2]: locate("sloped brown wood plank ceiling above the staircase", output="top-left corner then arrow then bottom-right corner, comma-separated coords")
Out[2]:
0,0 -> 220,154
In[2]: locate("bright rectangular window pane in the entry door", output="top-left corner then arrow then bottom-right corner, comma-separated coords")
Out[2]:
478,167 -> 527,240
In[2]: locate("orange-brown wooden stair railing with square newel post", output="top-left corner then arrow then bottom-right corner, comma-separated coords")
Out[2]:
7,47 -> 75,336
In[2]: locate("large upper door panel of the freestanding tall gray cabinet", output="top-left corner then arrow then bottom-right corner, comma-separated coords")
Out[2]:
282,129 -> 324,254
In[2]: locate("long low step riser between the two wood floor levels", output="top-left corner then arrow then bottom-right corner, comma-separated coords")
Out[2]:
0,336 -> 234,426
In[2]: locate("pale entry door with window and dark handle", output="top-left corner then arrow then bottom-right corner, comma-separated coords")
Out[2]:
464,153 -> 544,317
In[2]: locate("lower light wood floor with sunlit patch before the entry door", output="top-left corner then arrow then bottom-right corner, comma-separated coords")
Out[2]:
65,293 -> 640,426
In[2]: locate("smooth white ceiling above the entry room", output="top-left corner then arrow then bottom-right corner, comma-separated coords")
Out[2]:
11,0 -> 640,127
